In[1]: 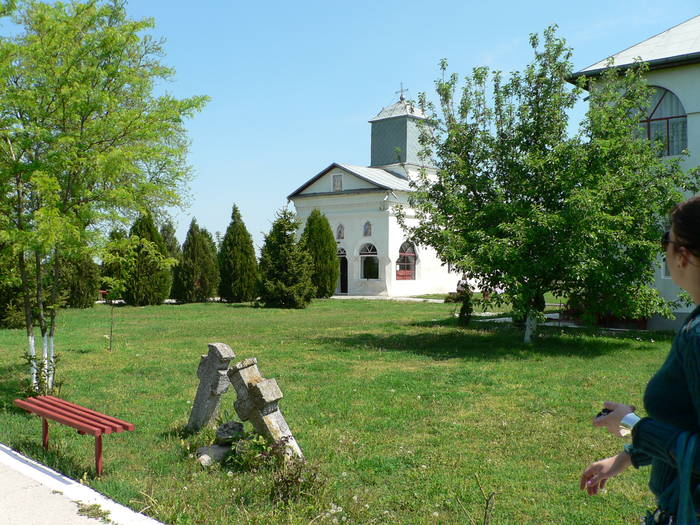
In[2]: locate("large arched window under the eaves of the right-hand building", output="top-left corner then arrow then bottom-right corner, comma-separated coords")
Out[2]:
640,87 -> 688,156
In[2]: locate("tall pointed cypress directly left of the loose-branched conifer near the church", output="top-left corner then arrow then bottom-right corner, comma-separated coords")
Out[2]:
219,204 -> 258,303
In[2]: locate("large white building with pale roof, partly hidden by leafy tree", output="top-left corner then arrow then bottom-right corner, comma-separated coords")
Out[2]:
574,16 -> 700,329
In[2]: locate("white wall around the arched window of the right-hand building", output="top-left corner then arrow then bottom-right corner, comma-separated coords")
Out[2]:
647,64 -> 700,329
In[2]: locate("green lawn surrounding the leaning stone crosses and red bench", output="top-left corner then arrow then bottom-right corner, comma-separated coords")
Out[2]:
0,300 -> 670,525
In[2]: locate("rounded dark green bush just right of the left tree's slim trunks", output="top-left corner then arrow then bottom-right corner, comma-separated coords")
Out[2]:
60,252 -> 100,308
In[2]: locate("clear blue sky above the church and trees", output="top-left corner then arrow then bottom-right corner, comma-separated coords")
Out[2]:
123,0 -> 700,248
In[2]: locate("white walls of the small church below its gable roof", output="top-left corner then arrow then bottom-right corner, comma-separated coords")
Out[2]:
293,192 -> 459,297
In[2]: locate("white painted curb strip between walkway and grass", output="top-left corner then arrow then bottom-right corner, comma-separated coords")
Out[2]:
0,443 -> 163,525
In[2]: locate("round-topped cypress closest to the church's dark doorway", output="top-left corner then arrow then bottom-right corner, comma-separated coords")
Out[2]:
301,209 -> 340,298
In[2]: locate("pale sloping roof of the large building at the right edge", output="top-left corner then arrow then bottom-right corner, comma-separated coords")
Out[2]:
572,15 -> 700,78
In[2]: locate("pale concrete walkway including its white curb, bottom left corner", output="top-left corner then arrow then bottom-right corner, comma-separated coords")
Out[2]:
0,443 -> 162,525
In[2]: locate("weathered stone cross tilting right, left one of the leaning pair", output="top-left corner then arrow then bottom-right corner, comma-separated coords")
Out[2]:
187,343 -> 236,432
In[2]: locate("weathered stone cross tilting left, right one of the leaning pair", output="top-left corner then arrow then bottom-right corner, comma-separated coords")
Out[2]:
228,357 -> 304,458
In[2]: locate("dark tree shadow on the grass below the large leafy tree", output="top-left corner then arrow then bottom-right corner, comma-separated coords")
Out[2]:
314,323 -> 660,361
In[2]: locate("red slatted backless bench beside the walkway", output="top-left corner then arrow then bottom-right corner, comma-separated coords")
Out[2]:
15,396 -> 134,476
